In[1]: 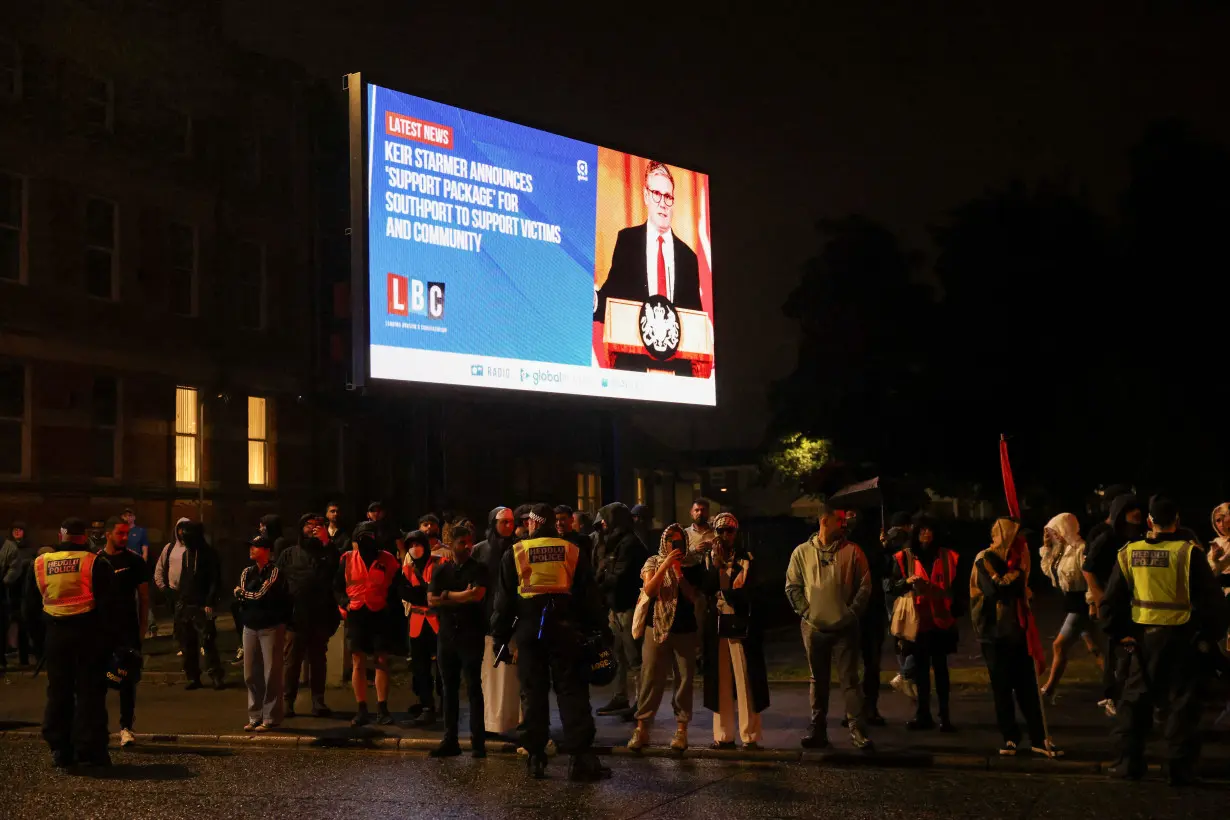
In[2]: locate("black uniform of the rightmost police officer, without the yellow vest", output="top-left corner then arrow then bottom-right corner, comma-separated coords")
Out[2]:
1100,534 -> 1230,777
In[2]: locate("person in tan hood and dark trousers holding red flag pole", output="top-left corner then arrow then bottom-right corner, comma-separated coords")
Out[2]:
969,518 -> 1063,757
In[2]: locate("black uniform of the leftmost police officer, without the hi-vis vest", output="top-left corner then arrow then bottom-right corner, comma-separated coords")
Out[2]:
23,543 -> 112,761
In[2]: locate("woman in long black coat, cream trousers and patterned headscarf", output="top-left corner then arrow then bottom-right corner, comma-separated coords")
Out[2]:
702,513 -> 769,751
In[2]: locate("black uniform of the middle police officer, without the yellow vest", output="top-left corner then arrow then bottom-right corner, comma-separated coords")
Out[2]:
492,534 -> 608,755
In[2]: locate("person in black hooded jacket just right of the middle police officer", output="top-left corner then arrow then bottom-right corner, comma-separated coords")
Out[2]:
594,502 -> 649,719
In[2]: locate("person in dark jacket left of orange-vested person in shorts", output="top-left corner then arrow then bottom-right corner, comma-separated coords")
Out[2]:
276,513 -> 342,718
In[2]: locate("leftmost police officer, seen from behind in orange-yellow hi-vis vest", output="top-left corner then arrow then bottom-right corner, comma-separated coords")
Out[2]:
25,518 -> 111,768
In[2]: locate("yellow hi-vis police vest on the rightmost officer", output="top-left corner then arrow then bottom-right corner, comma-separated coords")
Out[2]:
1119,541 -> 1194,627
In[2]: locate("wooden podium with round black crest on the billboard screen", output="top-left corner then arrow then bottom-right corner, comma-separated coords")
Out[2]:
603,296 -> 713,379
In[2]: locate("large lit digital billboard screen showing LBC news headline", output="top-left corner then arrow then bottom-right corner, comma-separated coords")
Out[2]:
364,79 -> 716,406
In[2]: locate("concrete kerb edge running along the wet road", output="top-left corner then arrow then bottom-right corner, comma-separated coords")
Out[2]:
0,729 -> 1180,777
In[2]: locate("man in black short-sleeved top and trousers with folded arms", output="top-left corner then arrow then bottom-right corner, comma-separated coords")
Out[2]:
427,526 -> 490,757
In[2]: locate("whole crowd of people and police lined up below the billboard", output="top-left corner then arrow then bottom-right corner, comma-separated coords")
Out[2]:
9,493 -> 1230,783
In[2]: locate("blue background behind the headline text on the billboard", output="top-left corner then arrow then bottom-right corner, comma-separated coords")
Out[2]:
367,86 -> 598,366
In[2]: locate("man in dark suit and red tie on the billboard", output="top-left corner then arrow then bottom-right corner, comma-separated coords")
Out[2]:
594,162 -> 701,322
